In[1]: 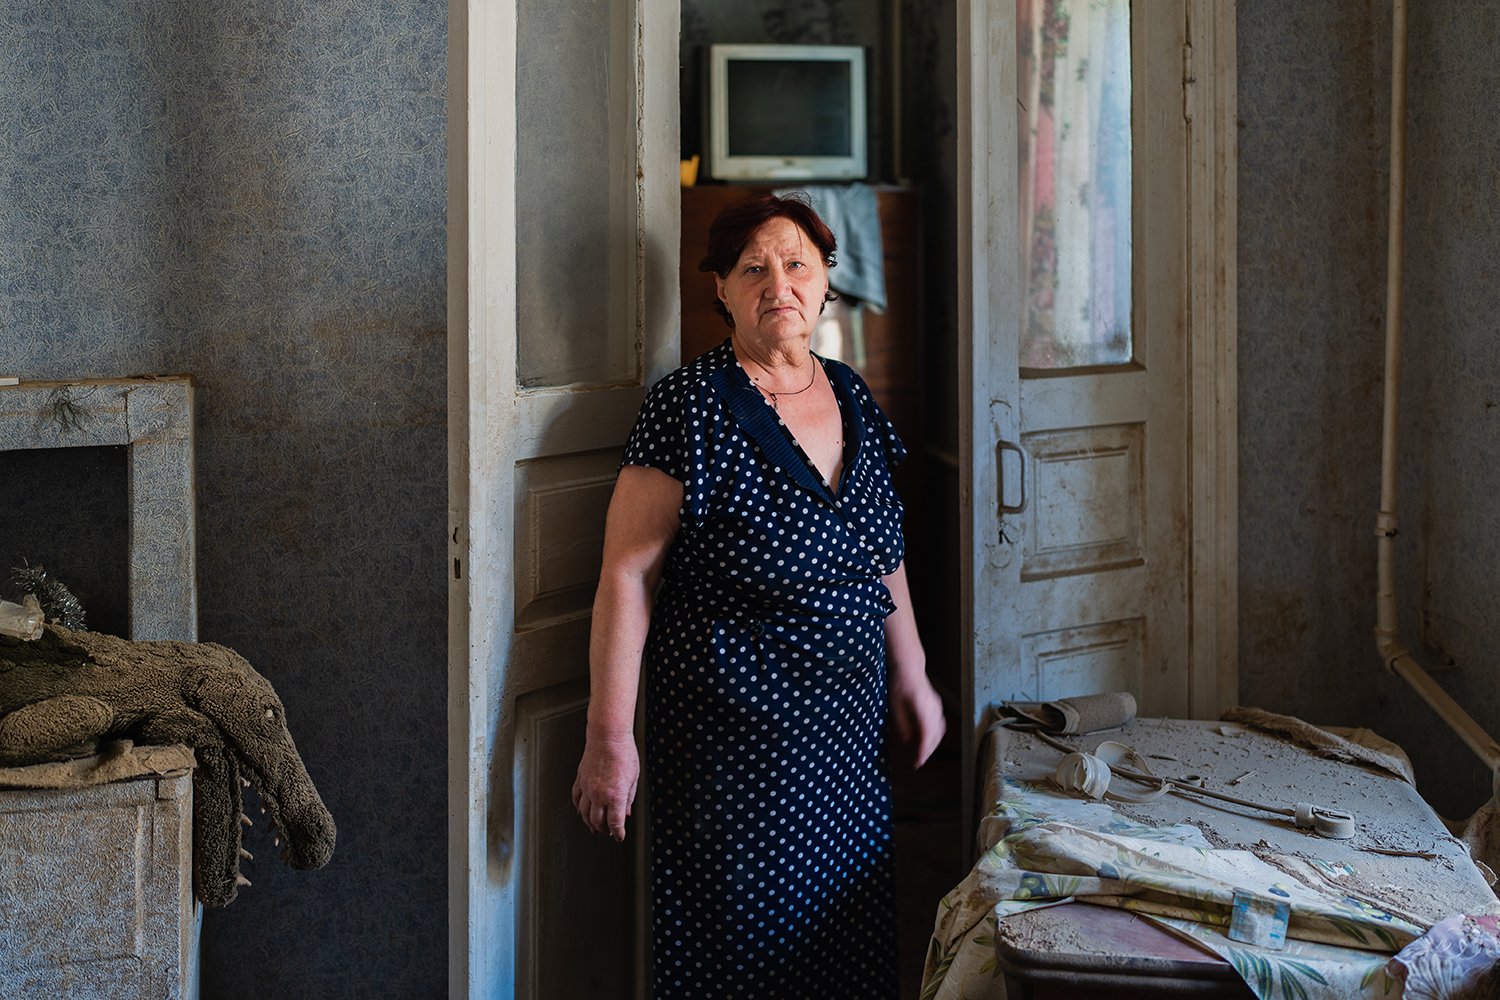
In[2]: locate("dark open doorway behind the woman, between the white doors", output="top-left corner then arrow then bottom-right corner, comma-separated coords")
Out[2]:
680,0 -> 968,996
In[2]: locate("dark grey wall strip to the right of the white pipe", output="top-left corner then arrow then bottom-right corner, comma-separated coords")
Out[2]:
1401,3 -> 1500,814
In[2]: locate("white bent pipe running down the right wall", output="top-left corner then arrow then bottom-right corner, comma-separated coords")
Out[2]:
1376,0 -> 1500,787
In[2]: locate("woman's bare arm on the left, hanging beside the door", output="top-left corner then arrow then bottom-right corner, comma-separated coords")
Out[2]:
573,465 -> 683,841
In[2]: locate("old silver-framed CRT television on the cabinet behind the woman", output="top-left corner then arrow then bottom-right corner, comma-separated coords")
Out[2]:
708,45 -> 869,180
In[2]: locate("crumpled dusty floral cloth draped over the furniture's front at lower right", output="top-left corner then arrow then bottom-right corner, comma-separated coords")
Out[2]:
921,714 -> 1500,1000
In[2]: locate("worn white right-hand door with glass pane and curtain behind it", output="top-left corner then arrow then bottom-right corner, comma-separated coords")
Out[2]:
1001,0 -> 1188,717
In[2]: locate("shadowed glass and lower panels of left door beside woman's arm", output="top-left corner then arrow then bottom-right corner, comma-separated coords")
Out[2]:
497,0 -> 675,983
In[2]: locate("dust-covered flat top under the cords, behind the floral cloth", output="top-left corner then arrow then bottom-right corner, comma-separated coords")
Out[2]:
1005,718 -> 1500,924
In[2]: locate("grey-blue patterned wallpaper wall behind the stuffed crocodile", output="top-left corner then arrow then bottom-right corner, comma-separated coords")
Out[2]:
0,0 -> 447,1000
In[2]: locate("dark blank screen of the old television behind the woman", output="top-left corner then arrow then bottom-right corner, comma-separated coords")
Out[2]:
728,58 -> 854,156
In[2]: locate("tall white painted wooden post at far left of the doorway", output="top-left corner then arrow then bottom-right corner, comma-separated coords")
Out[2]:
447,0 -> 518,1000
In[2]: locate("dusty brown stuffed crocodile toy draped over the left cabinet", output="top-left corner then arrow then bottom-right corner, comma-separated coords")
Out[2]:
0,624 -> 335,906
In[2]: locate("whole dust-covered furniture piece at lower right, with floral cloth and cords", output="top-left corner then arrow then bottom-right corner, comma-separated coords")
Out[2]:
921,709 -> 1500,1000
